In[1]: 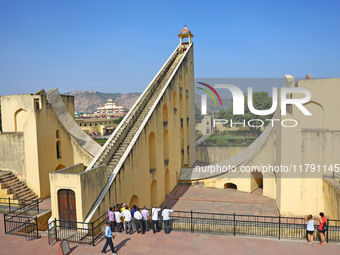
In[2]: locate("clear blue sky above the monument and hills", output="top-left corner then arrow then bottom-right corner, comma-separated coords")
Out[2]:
0,0 -> 340,95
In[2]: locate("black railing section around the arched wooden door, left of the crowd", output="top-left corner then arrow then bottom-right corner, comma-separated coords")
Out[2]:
48,213 -> 108,246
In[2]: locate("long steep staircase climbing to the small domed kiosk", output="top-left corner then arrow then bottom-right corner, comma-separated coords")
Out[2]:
91,47 -> 184,176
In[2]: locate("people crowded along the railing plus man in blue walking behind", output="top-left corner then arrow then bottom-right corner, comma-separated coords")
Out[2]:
102,203 -> 173,254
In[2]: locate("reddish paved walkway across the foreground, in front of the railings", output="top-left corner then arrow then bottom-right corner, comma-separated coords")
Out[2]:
0,219 -> 340,255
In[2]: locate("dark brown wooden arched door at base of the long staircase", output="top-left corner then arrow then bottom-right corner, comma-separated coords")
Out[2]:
58,189 -> 77,228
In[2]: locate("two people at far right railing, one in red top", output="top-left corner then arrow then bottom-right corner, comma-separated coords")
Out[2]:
305,212 -> 329,245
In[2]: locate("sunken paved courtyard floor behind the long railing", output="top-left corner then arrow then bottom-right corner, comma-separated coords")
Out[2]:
163,185 -> 278,216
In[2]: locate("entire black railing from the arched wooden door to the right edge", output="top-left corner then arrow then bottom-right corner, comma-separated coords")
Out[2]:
48,210 -> 340,245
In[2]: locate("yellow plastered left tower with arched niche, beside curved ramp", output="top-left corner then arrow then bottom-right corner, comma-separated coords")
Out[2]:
1,94 -> 93,198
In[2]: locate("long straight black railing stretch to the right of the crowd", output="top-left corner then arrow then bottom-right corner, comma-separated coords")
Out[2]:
170,211 -> 340,242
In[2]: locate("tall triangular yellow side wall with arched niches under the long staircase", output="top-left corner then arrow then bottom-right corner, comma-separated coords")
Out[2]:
77,45 -> 195,220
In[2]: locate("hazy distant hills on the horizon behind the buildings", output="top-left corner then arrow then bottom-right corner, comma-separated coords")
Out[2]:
62,91 -> 231,113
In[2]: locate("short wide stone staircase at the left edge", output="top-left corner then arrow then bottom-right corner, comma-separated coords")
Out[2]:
0,171 -> 38,200
